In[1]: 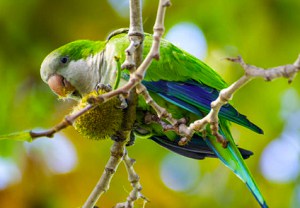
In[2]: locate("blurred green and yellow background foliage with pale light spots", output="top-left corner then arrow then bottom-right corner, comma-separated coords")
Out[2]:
0,0 -> 300,208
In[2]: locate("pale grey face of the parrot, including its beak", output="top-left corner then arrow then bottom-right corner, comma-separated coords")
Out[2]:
41,51 -> 99,100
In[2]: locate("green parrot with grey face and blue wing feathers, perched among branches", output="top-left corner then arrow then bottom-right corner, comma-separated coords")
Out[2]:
41,30 -> 267,207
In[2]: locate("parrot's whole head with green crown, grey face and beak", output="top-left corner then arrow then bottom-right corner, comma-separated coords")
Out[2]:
41,40 -> 105,100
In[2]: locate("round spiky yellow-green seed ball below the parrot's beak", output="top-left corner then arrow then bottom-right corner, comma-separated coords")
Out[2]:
73,90 -> 124,140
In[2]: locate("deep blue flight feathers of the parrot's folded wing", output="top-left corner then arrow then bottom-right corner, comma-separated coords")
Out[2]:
143,80 -> 263,134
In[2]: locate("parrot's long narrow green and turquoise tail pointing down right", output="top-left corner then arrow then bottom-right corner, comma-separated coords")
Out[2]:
206,119 -> 268,208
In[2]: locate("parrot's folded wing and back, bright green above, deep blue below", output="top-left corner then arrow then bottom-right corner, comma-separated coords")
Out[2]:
109,31 -> 262,133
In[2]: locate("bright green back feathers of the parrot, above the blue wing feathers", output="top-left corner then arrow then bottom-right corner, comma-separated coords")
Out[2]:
108,34 -> 227,90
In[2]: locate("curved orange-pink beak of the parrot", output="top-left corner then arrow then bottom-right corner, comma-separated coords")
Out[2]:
48,74 -> 76,97
